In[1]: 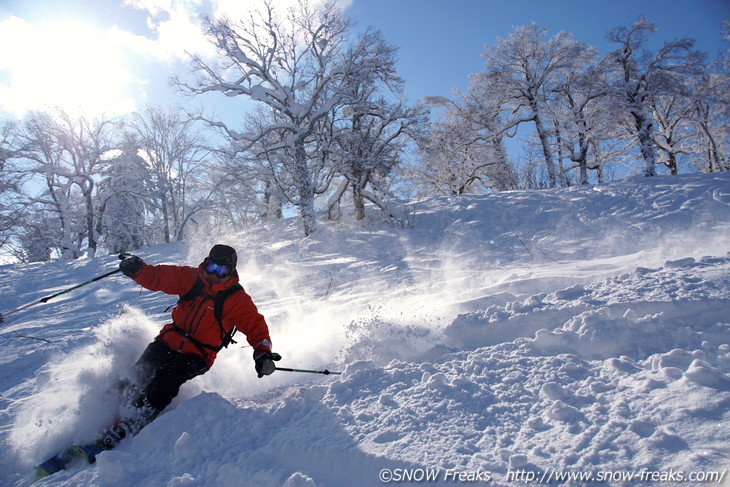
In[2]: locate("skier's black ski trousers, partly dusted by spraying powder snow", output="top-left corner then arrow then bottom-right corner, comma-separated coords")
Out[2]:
125,340 -> 208,434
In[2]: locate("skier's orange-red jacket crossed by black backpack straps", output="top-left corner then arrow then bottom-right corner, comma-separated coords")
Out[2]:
134,264 -> 271,368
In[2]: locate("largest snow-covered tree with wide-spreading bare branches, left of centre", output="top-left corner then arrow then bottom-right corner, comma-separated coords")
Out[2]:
184,1 -> 406,235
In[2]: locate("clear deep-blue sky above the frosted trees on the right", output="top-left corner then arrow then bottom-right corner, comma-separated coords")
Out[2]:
347,0 -> 730,103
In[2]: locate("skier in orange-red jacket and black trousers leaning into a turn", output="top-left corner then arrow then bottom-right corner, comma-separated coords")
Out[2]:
36,244 -> 281,478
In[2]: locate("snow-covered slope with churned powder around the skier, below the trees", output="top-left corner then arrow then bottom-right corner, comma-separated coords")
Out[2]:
0,174 -> 730,487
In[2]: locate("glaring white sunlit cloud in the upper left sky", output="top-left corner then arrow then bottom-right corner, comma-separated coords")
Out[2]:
0,0 -> 352,117
